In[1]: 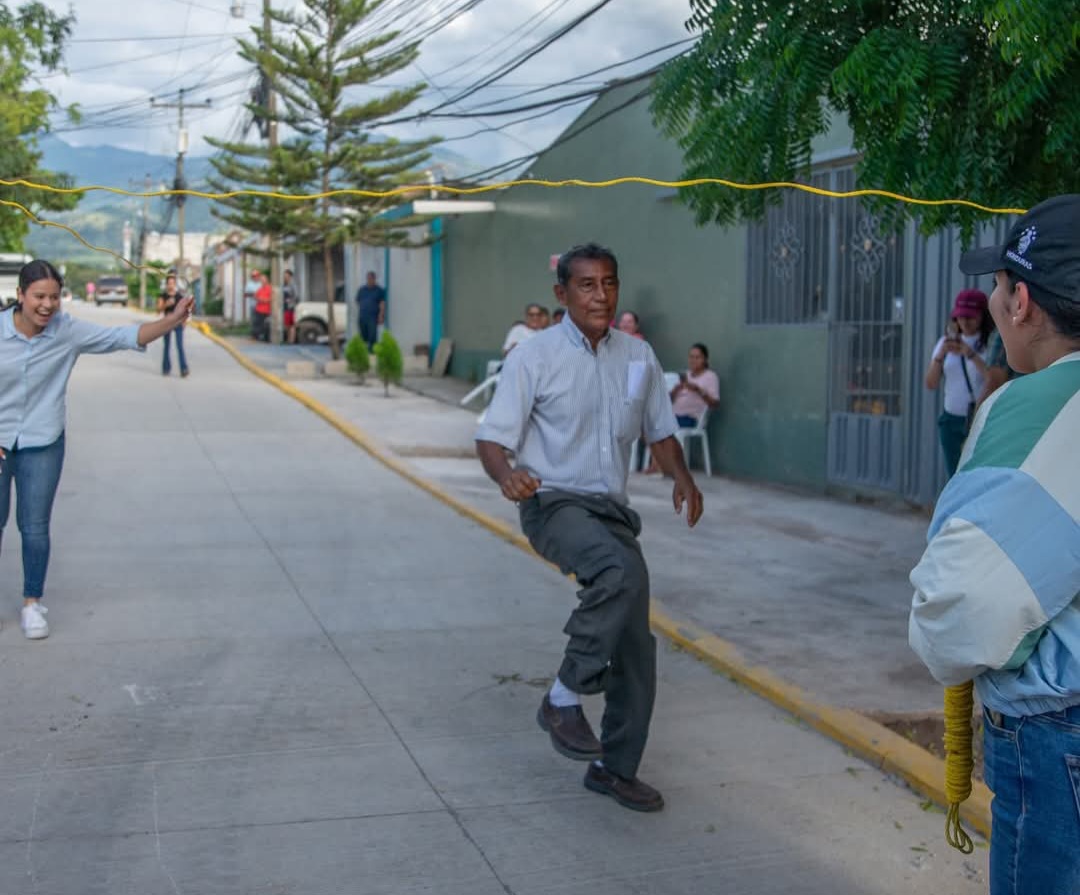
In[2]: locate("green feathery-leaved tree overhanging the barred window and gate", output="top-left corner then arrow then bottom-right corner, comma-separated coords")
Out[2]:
652,0 -> 1080,234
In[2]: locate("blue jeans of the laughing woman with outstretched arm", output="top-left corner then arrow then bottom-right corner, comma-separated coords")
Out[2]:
0,434 -> 64,598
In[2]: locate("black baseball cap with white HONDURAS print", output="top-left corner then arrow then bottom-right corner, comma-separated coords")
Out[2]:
960,193 -> 1080,301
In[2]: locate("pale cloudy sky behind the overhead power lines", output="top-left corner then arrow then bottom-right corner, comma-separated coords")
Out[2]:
43,0 -> 689,172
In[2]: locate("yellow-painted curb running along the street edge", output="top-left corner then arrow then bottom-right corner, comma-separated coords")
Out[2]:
192,323 -> 990,837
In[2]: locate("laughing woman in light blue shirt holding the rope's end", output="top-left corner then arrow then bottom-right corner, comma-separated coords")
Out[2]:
0,261 -> 192,640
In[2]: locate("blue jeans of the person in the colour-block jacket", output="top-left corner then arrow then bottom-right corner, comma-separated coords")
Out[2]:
983,706 -> 1080,895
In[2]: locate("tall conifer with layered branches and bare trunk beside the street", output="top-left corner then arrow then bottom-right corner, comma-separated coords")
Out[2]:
207,0 -> 433,357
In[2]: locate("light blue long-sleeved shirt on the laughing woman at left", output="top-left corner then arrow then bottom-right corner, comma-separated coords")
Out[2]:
0,311 -> 141,450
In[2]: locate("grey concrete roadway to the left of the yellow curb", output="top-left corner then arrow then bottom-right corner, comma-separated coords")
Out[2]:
0,309 -> 987,895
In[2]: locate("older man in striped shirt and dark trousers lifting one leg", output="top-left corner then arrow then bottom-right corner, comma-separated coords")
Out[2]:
476,244 -> 702,811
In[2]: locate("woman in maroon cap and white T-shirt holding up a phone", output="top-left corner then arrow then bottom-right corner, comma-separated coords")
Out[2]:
926,289 -> 994,477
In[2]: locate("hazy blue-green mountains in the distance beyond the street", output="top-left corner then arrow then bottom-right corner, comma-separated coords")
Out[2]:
26,135 -> 480,268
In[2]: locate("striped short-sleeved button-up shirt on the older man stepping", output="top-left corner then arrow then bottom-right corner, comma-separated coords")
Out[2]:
476,315 -> 678,503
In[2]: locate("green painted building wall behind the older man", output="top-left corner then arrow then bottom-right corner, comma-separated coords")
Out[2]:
444,85 -> 842,488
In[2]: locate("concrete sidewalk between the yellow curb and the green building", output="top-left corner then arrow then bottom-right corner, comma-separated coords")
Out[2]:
238,338 -> 942,715
